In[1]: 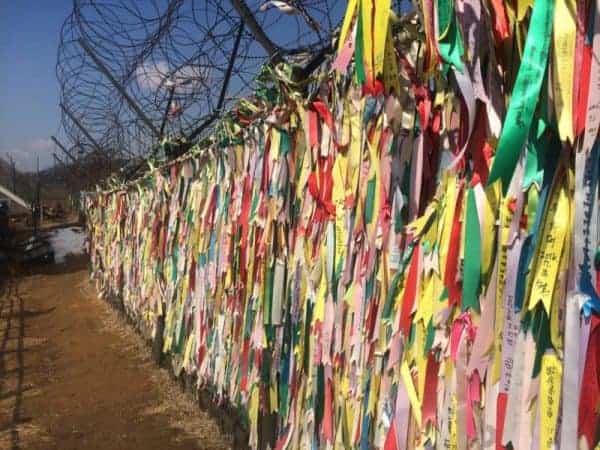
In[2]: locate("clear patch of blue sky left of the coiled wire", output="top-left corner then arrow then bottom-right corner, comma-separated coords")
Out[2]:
0,0 -> 72,170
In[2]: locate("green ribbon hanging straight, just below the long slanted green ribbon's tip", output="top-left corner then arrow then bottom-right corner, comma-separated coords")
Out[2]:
462,188 -> 481,311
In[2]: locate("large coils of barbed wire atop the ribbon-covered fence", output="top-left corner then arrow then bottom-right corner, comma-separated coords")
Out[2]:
56,0 -> 408,167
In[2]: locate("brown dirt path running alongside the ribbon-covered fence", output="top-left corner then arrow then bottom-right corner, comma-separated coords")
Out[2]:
0,260 -> 231,450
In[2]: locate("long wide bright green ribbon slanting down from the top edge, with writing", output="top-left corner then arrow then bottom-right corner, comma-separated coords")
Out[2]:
487,0 -> 554,194
